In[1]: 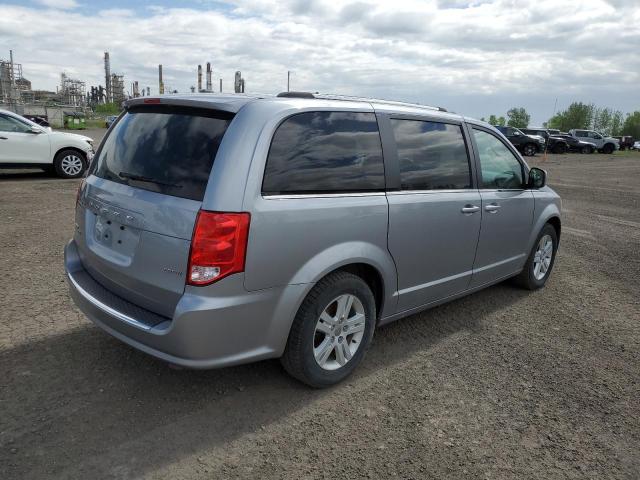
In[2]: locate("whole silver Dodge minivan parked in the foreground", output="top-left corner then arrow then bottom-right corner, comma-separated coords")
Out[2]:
65,92 -> 560,387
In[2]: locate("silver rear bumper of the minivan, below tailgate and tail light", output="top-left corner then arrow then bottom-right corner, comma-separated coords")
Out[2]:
65,240 -> 308,368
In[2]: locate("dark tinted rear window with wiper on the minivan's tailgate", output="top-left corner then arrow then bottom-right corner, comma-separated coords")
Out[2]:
92,105 -> 233,201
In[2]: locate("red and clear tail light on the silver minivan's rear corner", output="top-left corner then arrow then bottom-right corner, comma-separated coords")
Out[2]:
187,210 -> 250,285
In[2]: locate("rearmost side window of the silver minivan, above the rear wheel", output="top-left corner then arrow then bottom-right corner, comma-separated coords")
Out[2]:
262,112 -> 385,194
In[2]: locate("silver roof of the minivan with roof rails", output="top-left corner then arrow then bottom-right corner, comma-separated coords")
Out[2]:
125,92 -> 461,118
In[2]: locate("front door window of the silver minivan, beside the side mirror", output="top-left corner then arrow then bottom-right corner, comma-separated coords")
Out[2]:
473,128 -> 524,188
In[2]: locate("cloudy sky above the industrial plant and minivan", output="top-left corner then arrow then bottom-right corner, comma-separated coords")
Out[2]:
0,0 -> 640,125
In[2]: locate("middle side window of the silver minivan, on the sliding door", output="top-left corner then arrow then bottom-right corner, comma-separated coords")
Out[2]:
391,119 -> 471,190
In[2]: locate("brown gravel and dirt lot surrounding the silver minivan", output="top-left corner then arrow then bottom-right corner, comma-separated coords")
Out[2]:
0,145 -> 640,479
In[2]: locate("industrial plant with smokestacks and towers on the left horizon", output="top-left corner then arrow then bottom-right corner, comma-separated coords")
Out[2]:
0,50 -> 250,127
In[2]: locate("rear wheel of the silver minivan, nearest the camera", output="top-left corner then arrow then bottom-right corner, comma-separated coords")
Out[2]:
281,272 -> 376,388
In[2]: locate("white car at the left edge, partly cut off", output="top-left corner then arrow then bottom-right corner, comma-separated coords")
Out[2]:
0,110 -> 93,178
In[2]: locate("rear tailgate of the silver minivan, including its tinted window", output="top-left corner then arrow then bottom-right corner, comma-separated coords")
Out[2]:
75,105 -> 232,317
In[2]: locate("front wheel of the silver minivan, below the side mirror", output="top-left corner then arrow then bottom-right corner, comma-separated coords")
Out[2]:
515,223 -> 558,290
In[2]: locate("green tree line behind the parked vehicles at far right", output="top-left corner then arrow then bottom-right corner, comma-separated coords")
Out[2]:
482,102 -> 640,139
